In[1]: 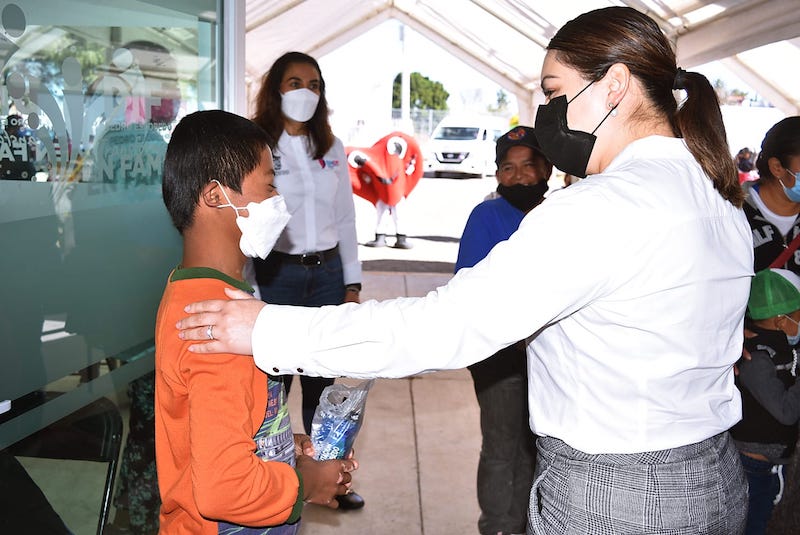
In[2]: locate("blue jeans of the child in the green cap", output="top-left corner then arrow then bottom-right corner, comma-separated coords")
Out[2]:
739,453 -> 783,535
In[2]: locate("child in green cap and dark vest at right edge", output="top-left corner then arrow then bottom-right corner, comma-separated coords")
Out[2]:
731,269 -> 800,533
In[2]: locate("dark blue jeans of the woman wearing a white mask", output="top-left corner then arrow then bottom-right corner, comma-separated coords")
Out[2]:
254,254 -> 345,433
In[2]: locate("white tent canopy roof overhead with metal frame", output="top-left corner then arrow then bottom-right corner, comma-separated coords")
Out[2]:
245,0 -> 800,124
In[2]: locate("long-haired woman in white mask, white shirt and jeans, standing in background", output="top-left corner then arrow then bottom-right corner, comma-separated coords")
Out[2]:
253,52 -> 364,509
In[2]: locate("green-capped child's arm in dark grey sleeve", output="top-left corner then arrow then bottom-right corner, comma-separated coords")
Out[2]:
739,351 -> 800,425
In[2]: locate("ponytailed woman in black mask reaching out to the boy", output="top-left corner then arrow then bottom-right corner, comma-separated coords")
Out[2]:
176,7 -> 753,535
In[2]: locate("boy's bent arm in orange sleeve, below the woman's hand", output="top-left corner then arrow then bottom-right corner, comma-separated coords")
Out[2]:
180,353 -> 303,526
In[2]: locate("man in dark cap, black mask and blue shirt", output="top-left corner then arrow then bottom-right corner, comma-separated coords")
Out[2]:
456,126 -> 553,535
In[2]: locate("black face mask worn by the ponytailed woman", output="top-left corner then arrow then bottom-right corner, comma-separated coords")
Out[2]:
534,82 -> 616,178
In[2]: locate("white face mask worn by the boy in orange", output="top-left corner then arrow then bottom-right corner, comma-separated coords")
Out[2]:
214,180 -> 292,259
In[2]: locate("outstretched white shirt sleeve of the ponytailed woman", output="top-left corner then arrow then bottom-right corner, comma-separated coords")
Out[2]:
247,188 -> 636,378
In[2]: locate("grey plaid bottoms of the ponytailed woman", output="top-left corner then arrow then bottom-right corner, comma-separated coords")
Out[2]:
528,432 -> 747,535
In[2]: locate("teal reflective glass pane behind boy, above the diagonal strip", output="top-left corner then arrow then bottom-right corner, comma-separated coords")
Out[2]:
0,0 -> 218,399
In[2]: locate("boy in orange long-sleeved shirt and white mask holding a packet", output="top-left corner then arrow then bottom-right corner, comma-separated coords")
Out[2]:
155,110 -> 357,535
